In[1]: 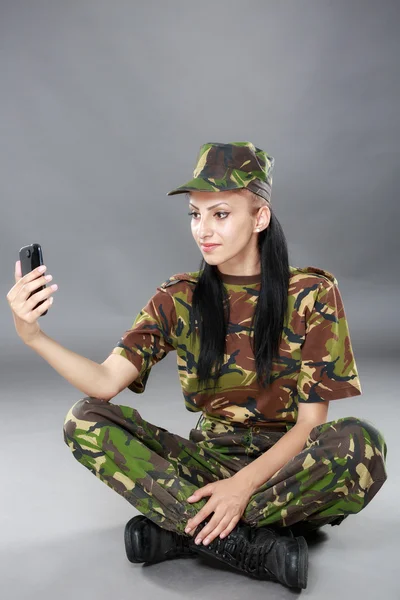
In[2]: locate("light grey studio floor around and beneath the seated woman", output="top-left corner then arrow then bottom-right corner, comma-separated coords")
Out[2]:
0,354 -> 400,600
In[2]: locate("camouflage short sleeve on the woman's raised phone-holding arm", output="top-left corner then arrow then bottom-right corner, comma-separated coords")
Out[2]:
111,287 -> 176,394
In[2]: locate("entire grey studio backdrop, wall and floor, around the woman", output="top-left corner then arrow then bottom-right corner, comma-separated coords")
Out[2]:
0,0 -> 400,599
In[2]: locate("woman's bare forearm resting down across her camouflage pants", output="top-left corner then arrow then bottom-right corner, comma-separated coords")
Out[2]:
234,422 -> 313,494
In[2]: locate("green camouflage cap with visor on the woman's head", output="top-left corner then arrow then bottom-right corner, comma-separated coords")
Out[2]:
167,142 -> 275,202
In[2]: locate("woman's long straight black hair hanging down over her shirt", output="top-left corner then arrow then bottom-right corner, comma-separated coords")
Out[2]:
192,190 -> 290,392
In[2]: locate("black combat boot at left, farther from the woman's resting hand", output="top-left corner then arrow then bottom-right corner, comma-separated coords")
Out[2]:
124,515 -> 196,563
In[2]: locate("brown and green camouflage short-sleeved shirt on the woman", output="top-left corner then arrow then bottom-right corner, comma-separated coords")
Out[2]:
112,266 -> 361,431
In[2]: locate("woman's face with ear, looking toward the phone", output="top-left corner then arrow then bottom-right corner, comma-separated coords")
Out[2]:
189,191 -> 270,274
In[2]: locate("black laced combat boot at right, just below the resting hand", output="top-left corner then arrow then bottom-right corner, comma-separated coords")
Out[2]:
189,520 -> 308,589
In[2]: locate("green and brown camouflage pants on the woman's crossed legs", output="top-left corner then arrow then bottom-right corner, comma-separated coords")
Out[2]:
64,397 -> 387,535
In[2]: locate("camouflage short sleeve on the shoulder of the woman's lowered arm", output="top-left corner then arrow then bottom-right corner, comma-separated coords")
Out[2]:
297,280 -> 362,402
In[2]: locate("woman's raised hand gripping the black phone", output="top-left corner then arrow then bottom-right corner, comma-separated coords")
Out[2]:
7,260 -> 58,344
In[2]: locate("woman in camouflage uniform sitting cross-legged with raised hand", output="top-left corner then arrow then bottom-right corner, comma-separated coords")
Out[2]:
8,142 -> 387,588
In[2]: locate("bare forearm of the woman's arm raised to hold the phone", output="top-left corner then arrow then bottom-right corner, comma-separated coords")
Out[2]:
26,331 -> 113,400
